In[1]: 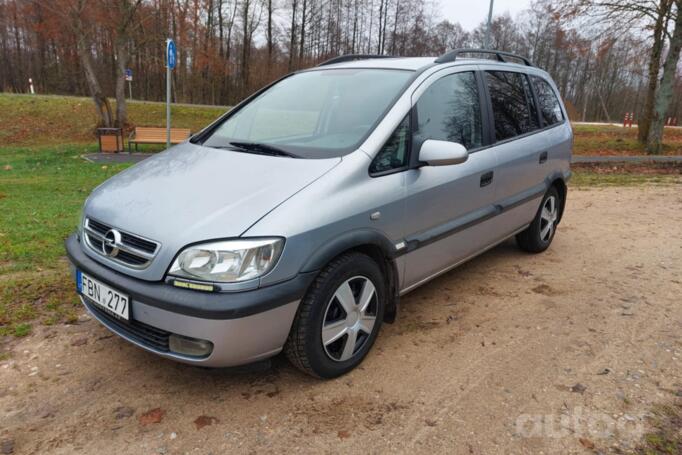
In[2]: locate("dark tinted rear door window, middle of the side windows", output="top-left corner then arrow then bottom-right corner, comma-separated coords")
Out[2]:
486,71 -> 538,141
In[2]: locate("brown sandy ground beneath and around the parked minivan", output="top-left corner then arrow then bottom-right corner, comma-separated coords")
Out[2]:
0,186 -> 682,454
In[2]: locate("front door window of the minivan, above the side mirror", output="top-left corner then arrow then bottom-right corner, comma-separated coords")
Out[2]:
416,72 -> 483,149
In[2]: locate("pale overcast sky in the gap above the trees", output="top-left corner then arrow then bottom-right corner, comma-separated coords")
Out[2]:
440,0 -> 530,31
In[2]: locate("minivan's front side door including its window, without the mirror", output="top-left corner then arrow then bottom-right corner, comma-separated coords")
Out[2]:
403,66 -> 497,291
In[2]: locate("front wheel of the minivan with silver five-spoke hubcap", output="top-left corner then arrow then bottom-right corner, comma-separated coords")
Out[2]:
284,252 -> 387,379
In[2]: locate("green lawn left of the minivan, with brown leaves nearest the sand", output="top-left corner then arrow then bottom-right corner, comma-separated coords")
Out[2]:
0,145 -> 133,336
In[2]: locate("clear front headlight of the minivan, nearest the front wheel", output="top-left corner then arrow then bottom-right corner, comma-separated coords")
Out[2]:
169,238 -> 284,283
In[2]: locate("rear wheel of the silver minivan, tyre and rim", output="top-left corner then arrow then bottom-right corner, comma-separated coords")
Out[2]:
516,186 -> 561,253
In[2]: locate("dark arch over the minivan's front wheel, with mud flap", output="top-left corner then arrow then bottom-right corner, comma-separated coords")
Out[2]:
301,229 -> 400,323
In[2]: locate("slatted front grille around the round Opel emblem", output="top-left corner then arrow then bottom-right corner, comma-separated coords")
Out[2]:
84,218 -> 159,269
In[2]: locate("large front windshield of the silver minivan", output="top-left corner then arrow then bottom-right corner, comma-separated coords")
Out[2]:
203,69 -> 413,158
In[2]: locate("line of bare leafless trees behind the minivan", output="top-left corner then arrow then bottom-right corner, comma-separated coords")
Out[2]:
0,0 -> 682,127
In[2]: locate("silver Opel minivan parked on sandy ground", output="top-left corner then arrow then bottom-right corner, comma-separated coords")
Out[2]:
66,49 -> 573,378
